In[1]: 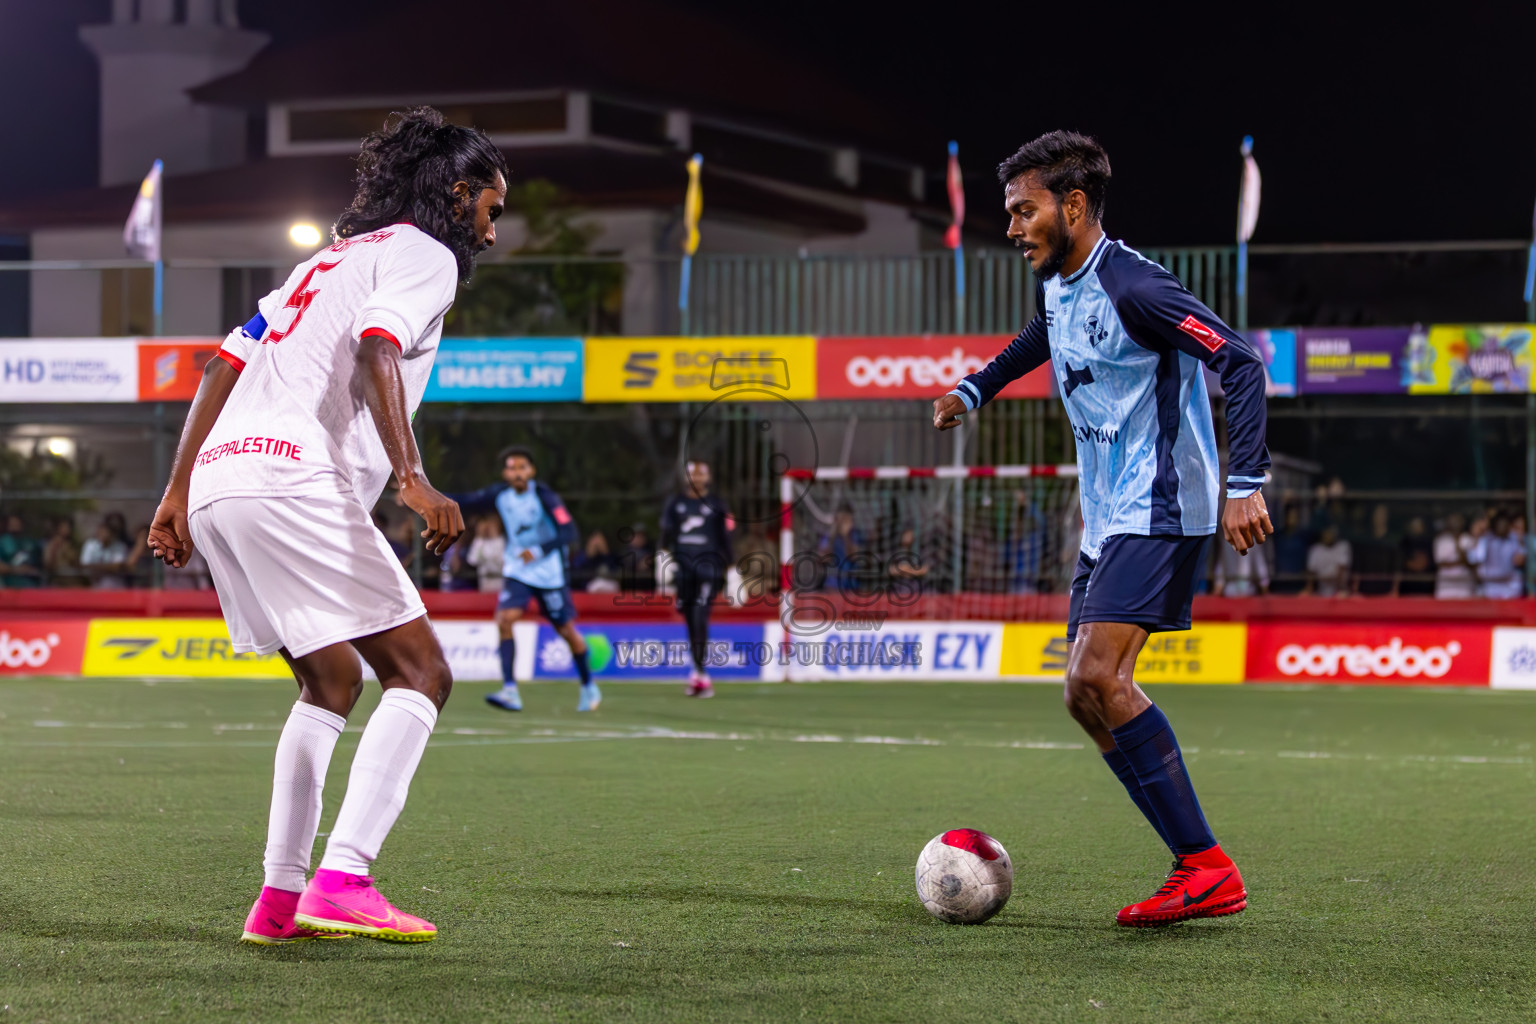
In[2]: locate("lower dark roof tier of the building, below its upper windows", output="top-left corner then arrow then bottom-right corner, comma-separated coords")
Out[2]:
0,146 -> 865,233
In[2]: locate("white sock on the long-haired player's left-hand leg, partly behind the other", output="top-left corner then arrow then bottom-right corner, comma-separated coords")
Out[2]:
261,702 -> 347,892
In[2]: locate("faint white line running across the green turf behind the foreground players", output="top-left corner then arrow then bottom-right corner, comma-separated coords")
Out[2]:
14,718 -> 1536,766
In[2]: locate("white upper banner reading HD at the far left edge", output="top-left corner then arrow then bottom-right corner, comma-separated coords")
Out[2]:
0,338 -> 138,402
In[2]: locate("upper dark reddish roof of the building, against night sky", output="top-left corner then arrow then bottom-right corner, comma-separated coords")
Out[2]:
190,0 -> 937,163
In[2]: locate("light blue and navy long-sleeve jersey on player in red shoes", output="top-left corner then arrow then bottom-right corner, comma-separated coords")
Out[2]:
951,238 -> 1269,559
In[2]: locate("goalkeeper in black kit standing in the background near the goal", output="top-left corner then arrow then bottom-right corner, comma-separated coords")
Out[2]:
662,462 -> 736,697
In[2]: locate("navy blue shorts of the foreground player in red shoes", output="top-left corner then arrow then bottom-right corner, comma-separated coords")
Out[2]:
1066,534 -> 1210,642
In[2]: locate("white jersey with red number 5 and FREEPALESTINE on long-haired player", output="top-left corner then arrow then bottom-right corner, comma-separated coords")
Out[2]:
187,224 -> 459,510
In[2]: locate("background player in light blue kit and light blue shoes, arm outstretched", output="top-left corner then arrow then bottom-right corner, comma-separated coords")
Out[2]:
455,448 -> 602,711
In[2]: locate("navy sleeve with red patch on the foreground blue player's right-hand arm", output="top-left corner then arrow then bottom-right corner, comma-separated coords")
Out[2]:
1098,259 -> 1269,490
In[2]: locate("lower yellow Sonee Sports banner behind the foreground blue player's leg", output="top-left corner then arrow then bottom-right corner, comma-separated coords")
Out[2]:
1000,622 -> 1247,683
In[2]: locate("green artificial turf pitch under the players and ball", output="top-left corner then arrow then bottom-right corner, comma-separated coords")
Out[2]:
0,680 -> 1536,1024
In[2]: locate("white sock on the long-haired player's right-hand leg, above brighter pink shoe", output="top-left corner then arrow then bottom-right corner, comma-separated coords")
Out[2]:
319,686 -> 438,875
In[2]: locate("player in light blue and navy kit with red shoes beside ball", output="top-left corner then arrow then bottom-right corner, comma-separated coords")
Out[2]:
934,132 -> 1272,927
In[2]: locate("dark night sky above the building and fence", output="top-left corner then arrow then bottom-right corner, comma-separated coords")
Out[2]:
0,0 -> 1536,244
